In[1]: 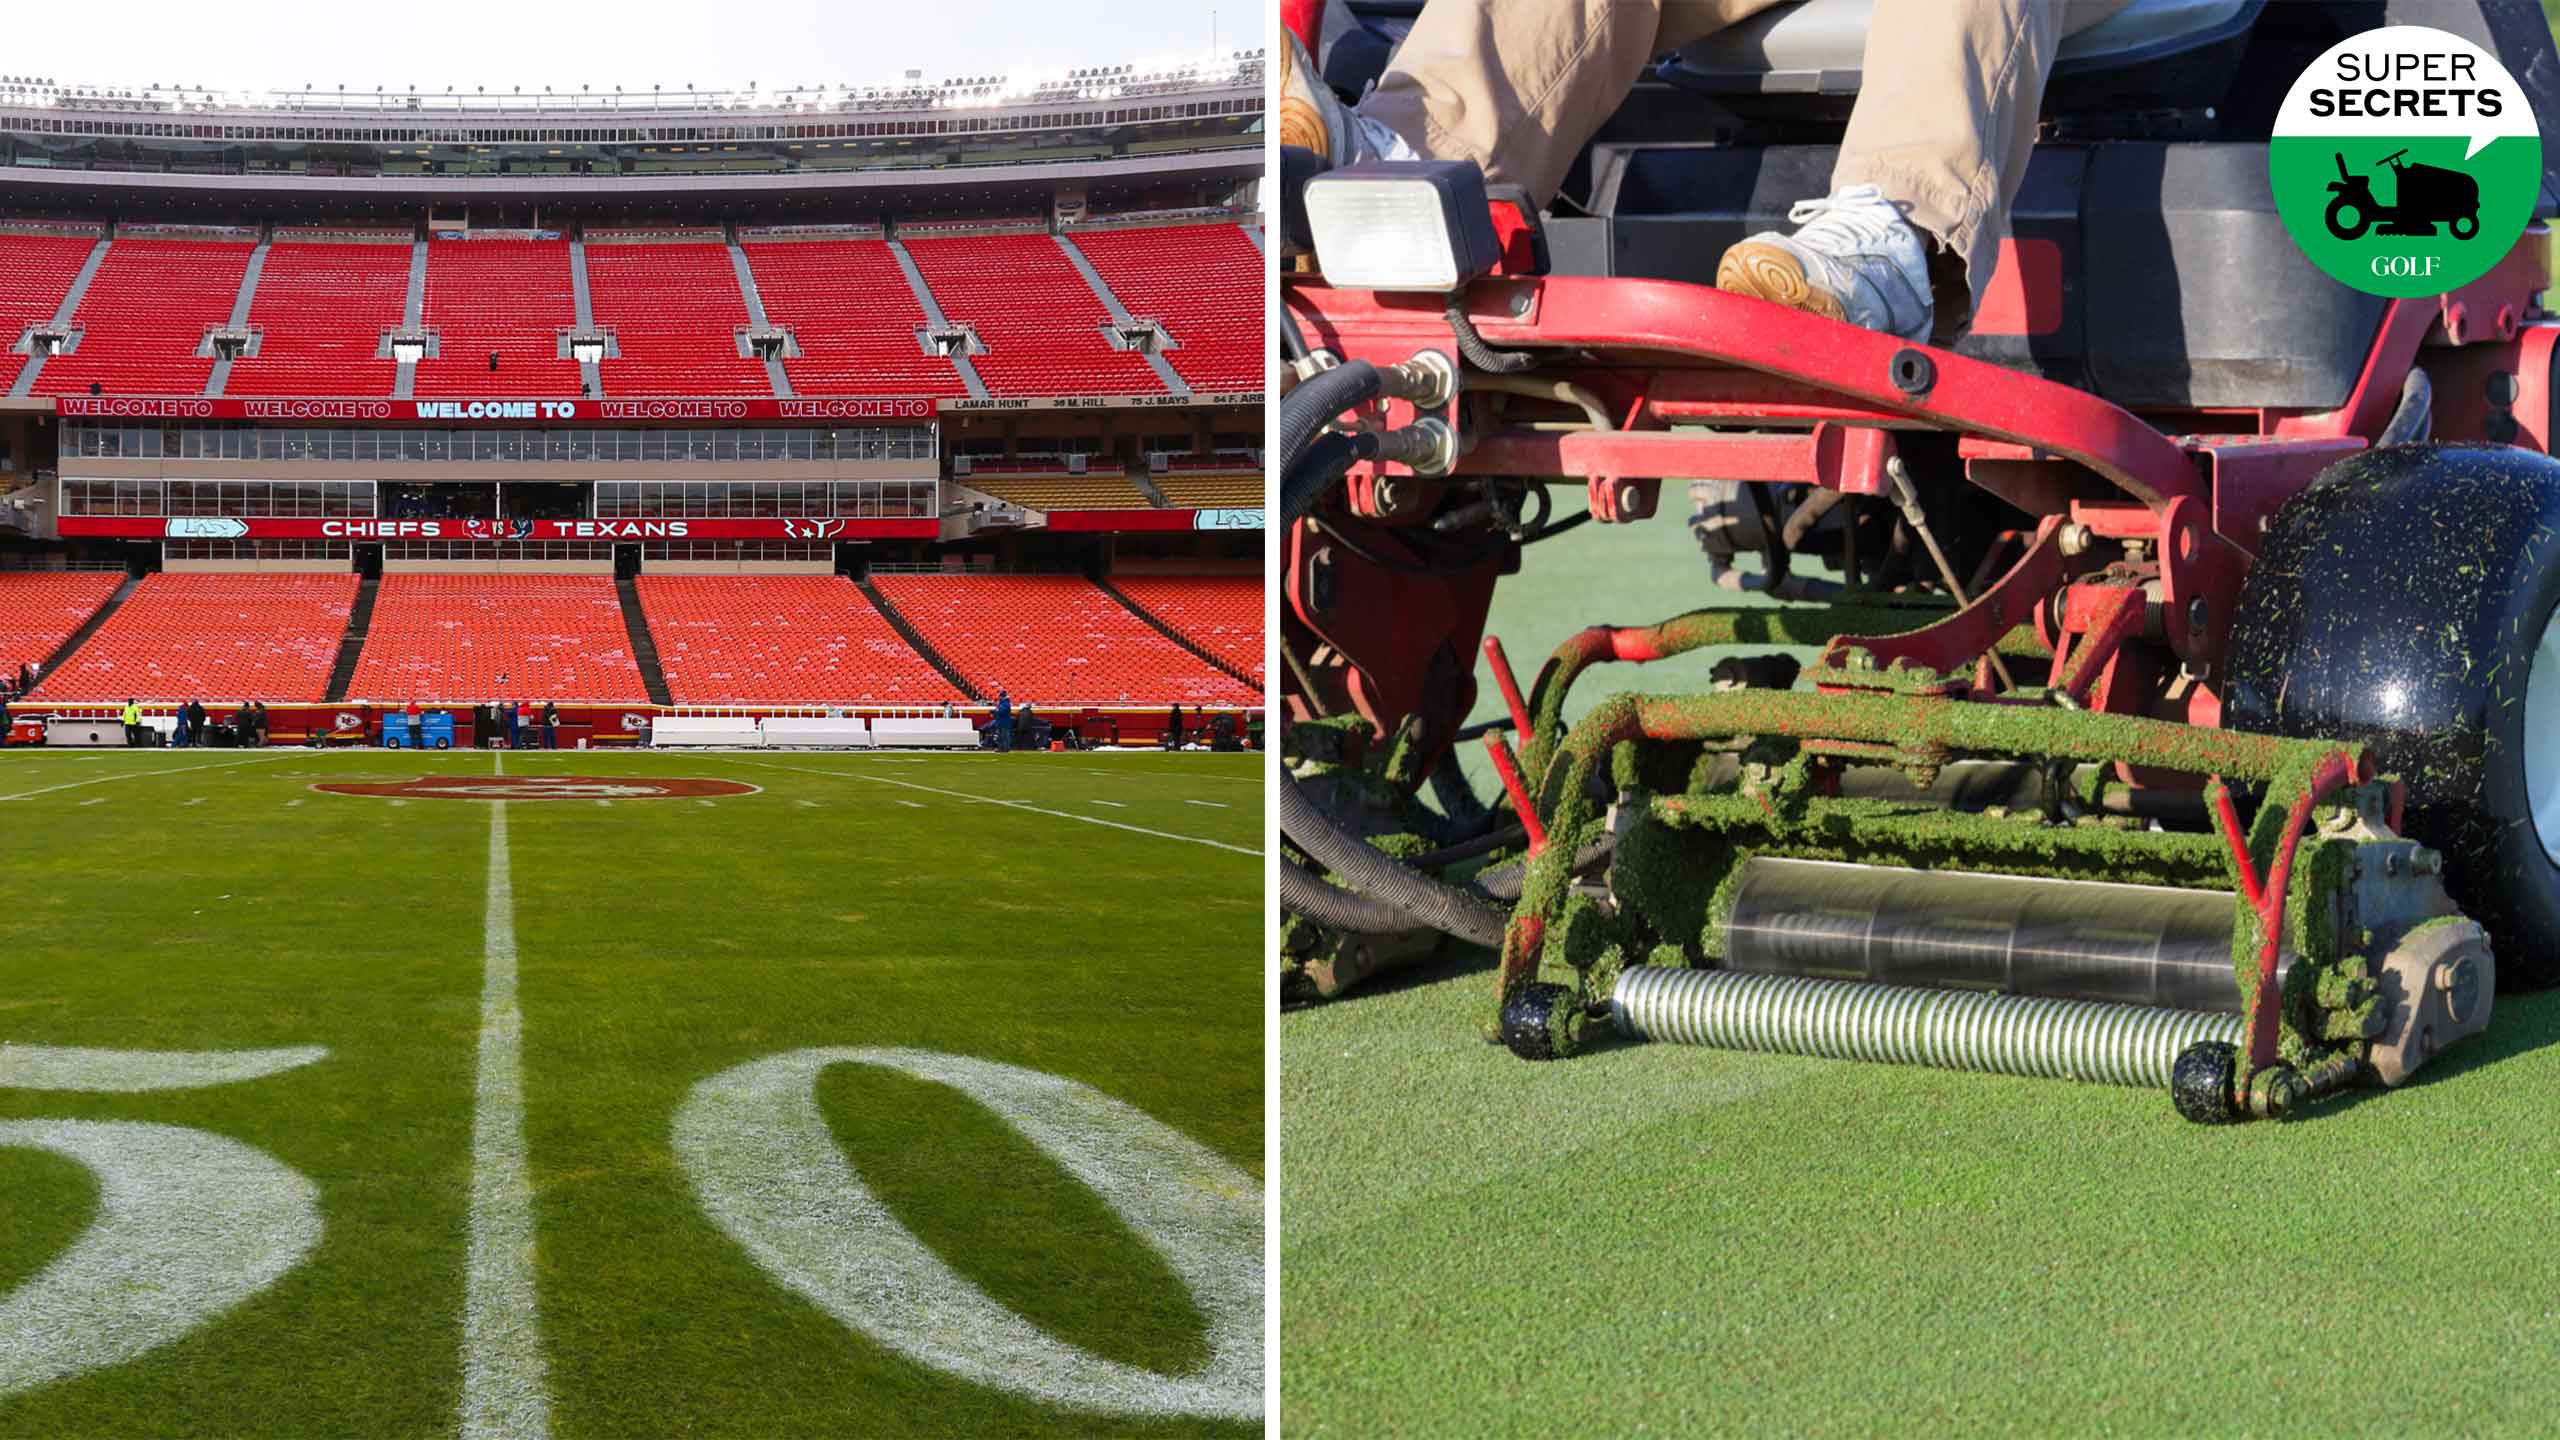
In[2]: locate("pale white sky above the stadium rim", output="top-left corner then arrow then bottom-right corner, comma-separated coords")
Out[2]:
0,0 -> 1270,92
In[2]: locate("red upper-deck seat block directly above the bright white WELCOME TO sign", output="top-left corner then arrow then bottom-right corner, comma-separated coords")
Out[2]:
417,241 -> 579,400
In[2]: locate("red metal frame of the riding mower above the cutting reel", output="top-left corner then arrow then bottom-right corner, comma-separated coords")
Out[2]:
1283,225 -> 2560,784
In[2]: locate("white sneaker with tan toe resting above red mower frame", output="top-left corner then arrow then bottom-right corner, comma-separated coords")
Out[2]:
1715,184 -> 1938,341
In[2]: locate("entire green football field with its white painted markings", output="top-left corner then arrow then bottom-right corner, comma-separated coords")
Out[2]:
0,751 -> 1265,1437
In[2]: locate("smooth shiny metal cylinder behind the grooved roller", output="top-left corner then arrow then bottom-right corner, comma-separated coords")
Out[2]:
1723,856 -> 2240,1015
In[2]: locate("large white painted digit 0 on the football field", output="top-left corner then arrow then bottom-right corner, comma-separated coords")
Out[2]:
676,1048 -> 1262,1420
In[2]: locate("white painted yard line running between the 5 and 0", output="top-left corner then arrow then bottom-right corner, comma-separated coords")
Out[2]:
463,753 -> 550,1440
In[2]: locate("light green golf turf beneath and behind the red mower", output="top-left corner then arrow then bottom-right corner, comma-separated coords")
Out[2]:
1280,487 -> 2560,1437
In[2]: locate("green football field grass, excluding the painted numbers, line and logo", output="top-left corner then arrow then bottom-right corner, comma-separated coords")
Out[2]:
0,751 -> 1262,1437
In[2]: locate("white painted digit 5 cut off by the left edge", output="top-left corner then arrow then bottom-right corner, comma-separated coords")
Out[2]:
0,1045 -> 328,1396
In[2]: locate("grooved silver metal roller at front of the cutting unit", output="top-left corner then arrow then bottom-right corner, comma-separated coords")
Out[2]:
1610,966 -> 2240,1089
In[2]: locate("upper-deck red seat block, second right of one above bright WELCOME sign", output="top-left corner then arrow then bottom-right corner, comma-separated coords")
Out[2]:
745,241 -> 968,397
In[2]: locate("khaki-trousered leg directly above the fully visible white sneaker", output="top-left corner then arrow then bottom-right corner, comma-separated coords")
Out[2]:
1830,0 -> 2127,336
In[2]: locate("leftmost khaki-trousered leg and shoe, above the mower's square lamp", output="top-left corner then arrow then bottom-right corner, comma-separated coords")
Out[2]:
1280,0 -> 1777,205
